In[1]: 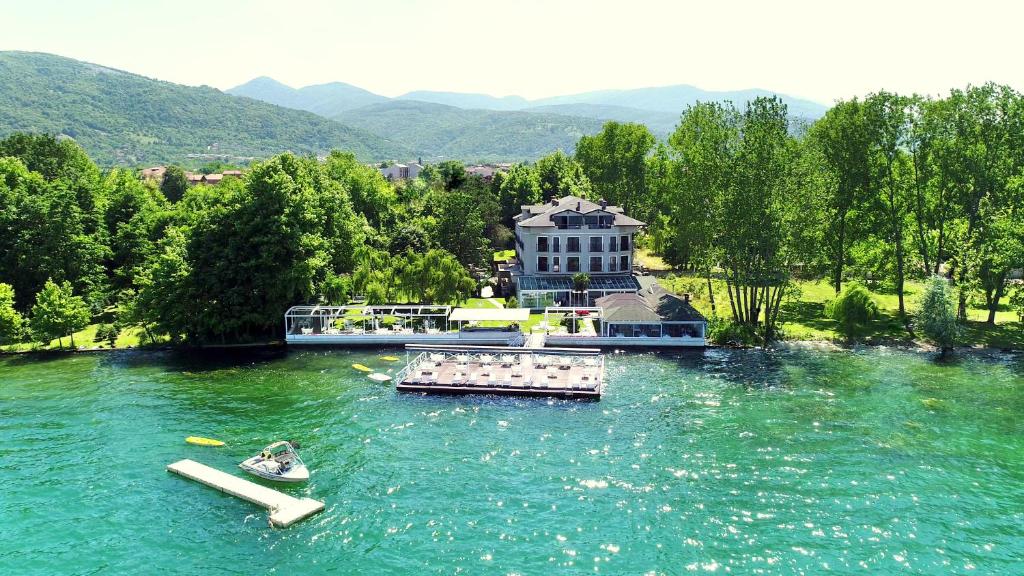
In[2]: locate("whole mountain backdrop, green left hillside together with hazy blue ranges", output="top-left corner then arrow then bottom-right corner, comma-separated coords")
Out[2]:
0,51 -> 825,166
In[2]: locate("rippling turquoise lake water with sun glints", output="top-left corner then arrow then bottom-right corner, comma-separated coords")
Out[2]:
0,349 -> 1024,574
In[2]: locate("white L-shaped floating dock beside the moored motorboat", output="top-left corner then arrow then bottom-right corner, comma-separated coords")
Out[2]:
167,459 -> 324,528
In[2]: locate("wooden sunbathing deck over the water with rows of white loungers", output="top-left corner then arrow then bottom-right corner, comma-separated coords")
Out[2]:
394,344 -> 604,400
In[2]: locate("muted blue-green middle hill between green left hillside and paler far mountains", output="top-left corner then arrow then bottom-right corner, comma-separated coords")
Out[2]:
336,99 -> 602,162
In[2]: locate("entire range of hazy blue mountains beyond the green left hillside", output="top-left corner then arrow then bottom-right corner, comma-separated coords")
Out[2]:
228,77 -> 827,161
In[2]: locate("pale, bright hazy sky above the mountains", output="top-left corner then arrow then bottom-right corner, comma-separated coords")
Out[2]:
0,0 -> 1024,104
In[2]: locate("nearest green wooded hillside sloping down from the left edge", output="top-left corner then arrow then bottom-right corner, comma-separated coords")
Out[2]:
0,52 -> 409,165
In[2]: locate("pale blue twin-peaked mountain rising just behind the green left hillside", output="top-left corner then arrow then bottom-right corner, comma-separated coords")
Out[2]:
227,76 -> 388,118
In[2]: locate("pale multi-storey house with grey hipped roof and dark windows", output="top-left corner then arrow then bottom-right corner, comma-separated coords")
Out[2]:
515,196 -> 645,308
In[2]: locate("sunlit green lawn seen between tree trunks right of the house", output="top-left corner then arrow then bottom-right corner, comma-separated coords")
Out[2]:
659,275 -> 1024,348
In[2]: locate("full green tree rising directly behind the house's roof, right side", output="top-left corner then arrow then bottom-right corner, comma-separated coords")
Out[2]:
575,122 -> 655,219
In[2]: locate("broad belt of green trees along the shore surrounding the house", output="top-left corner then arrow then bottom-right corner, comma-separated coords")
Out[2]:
0,84 -> 1024,345
